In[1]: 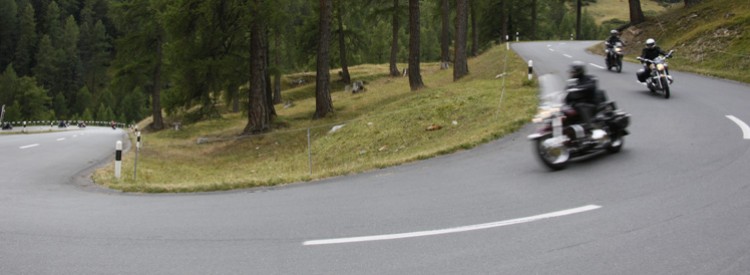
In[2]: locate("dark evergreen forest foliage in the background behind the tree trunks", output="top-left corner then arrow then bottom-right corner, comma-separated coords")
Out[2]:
0,0 -> 656,126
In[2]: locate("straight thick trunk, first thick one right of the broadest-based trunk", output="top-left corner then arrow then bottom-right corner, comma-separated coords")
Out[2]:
313,0 -> 333,119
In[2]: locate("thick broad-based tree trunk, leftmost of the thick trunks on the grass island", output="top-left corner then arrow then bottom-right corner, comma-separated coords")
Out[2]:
243,0 -> 270,135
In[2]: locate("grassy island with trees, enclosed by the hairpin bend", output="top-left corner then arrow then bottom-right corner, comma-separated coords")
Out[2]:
93,46 -> 538,192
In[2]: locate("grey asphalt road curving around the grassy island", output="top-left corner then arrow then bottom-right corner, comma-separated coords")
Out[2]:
0,42 -> 750,274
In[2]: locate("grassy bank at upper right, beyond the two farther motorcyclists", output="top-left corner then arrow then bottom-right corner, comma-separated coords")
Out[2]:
590,0 -> 750,83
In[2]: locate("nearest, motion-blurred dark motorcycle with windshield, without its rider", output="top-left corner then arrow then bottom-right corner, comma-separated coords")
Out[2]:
528,75 -> 630,170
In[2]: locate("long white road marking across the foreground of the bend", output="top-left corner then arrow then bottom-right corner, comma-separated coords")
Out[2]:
302,204 -> 601,245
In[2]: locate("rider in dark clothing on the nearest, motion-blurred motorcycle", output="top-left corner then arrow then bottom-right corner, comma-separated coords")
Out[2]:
565,61 -> 601,133
